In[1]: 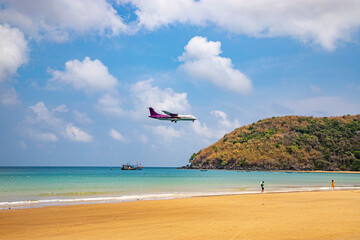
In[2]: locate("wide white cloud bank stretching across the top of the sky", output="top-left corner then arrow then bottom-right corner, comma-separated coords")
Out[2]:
0,0 -> 360,50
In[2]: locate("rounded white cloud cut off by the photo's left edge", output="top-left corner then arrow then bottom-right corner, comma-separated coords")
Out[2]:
0,24 -> 28,83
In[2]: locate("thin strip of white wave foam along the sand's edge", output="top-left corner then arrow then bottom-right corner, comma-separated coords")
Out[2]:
0,186 -> 360,210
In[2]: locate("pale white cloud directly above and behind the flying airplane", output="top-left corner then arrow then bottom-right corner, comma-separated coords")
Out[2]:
130,79 -> 190,117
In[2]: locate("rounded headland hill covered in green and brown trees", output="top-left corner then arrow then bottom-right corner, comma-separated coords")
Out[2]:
190,115 -> 360,170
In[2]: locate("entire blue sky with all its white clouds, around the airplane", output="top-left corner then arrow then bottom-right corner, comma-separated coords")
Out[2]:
0,0 -> 360,167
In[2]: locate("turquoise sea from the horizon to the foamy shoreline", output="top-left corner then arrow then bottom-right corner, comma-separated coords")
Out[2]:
0,167 -> 360,210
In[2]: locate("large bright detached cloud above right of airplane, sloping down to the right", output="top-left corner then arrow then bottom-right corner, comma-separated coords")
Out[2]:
179,36 -> 252,94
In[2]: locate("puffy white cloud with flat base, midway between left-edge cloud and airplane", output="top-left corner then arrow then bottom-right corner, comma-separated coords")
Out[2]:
50,57 -> 118,93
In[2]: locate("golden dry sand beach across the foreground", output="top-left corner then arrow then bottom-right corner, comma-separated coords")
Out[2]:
0,191 -> 360,240
